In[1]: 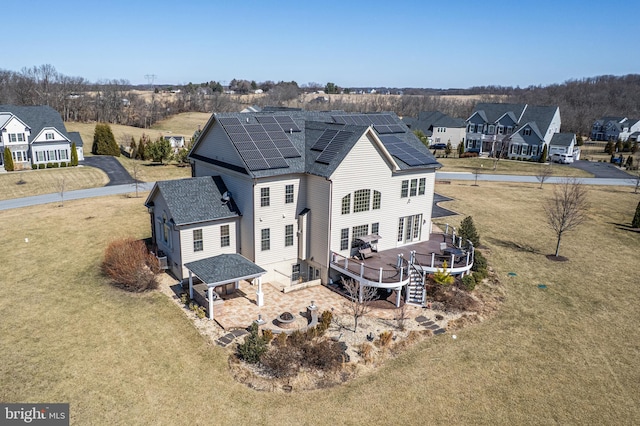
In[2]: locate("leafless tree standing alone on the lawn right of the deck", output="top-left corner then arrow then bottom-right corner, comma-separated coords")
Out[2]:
544,178 -> 589,257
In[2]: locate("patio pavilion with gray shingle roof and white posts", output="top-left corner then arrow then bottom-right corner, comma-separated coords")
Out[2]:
184,253 -> 267,320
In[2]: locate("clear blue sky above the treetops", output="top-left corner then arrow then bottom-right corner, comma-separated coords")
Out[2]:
6,0 -> 640,88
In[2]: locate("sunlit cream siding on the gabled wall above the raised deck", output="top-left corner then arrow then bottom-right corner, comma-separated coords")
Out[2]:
330,132 -> 435,256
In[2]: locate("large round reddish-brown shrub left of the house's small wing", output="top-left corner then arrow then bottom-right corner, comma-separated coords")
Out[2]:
102,238 -> 160,292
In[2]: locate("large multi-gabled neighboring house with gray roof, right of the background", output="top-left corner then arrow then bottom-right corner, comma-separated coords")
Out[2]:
465,103 -> 561,160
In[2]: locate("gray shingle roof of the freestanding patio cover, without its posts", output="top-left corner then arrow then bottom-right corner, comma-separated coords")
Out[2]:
184,253 -> 267,284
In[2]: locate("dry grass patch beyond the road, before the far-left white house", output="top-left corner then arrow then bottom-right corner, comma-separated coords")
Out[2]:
0,167 -> 109,200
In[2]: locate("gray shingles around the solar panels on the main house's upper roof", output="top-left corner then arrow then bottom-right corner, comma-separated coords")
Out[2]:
195,108 -> 440,178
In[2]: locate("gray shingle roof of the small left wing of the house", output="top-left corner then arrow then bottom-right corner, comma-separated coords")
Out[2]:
145,176 -> 240,225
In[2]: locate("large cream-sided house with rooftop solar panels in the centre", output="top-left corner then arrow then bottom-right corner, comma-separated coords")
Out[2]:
147,110 -> 440,316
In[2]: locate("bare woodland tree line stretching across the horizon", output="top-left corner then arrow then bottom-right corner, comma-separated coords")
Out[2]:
0,64 -> 640,135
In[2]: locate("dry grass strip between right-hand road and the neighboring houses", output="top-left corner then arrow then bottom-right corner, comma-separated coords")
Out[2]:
438,157 -> 593,177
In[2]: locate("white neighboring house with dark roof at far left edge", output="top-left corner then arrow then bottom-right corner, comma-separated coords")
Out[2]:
0,105 -> 84,170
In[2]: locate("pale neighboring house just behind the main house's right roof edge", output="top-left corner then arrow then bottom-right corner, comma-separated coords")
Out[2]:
402,111 -> 467,150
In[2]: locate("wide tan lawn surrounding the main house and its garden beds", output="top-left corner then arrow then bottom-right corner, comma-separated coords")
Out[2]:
0,182 -> 640,425
